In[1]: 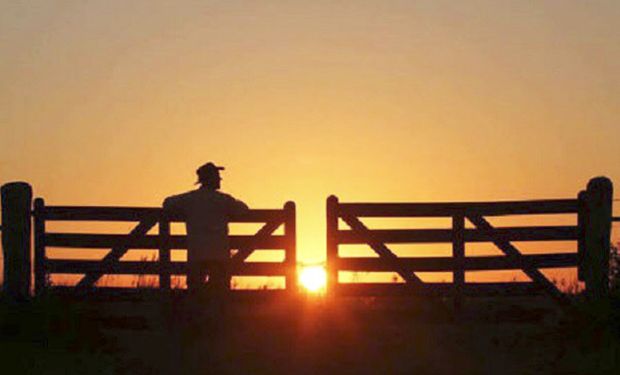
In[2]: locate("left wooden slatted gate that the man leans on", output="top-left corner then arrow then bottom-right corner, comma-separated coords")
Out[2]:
33,198 -> 297,296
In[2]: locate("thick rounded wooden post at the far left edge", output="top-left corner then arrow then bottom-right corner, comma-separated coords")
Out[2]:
1,182 -> 32,301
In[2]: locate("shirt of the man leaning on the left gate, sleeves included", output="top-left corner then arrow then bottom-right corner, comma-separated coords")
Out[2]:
163,187 -> 248,262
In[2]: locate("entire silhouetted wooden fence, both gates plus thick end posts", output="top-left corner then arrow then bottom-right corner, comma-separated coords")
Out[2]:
1,177 -> 613,303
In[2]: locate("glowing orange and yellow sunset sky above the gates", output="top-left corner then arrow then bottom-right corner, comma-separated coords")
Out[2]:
0,0 -> 620,284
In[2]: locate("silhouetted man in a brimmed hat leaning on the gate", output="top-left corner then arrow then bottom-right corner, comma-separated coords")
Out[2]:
163,162 -> 248,295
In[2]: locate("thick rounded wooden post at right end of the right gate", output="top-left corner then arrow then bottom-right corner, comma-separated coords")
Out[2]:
582,177 -> 613,299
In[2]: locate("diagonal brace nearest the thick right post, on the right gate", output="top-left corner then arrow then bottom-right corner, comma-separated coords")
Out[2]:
467,215 -> 570,304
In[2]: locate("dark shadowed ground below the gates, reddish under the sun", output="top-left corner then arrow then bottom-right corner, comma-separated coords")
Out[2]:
0,297 -> 620,374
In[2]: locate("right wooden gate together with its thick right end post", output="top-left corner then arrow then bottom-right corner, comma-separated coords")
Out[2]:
327,179 -> 611,305
